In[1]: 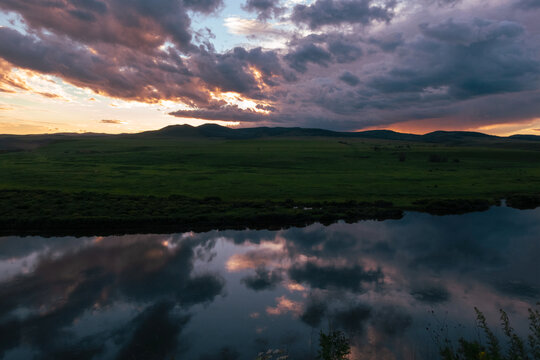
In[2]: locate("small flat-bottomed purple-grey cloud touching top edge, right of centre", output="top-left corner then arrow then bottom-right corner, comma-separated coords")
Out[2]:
291,0 -> 394,29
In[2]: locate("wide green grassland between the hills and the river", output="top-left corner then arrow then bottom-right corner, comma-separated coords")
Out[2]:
0,134 -> 540,232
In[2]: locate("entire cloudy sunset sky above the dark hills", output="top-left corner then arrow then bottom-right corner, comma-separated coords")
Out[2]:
0,0 -> 540,135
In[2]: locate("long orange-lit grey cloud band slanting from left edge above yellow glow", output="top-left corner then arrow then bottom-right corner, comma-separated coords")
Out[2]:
0,28 -> 287,106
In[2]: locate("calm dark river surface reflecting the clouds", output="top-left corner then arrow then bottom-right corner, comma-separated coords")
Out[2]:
0,207 -> 540,360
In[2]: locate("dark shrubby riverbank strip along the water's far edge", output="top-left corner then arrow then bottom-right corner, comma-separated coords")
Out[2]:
0,190 -> 540,236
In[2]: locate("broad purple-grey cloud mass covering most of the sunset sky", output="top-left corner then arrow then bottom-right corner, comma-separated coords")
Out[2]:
0,0 -> 540,130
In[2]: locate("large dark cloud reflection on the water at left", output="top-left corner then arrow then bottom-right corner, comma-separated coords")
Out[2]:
0,237 -> 224,353
